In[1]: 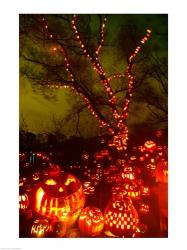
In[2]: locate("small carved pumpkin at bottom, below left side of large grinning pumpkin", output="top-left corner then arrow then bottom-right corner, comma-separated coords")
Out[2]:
31,219 -> 50,238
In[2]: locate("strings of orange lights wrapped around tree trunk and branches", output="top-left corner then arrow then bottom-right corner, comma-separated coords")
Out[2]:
38,15 -> 151,149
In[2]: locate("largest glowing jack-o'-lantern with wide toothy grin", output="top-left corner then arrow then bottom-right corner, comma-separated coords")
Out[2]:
34,174 -> 85,225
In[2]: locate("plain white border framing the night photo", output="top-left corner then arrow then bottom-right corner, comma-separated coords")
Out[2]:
0,0 -> 187,250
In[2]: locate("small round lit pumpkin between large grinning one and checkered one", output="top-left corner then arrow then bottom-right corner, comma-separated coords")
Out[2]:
79,206 -> 104,236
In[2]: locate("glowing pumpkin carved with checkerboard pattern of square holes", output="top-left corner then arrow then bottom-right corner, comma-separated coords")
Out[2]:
104,196 -> 139,237
